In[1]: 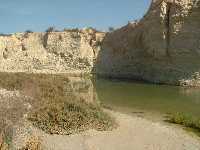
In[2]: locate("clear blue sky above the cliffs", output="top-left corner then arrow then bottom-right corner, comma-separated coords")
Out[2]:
0,0 -> 151,33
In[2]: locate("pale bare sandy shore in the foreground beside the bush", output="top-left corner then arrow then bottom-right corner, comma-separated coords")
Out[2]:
33,112 -> 200,150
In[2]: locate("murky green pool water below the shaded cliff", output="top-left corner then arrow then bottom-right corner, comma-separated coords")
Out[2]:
95,79 -> 200,116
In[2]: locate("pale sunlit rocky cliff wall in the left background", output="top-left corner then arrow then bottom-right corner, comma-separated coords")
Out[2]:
0,29 -> 105,73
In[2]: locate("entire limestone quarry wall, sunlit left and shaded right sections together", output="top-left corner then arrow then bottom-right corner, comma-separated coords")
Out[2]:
0,0 -> 200,84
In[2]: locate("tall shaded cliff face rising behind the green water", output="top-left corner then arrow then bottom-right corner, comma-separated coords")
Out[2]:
97,0 -> 200,84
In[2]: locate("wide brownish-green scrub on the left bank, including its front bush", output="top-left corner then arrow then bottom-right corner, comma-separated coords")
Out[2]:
0,73 -> 116,135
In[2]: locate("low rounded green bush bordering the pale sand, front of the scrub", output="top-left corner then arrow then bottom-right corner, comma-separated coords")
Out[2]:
29,100 -> 114,135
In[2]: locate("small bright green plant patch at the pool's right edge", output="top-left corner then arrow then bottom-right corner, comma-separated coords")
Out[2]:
167,113 -> 200,136
